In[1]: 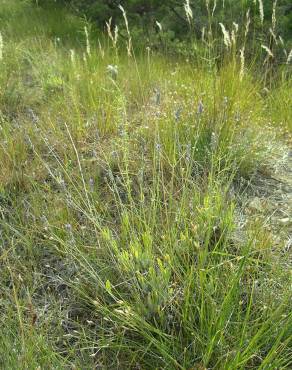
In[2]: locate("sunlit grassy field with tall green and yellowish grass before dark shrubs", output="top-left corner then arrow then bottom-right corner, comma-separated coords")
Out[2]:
0,0 -> 292,370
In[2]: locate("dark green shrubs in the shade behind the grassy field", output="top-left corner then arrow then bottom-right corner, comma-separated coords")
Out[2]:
36,0 -> 292,51
